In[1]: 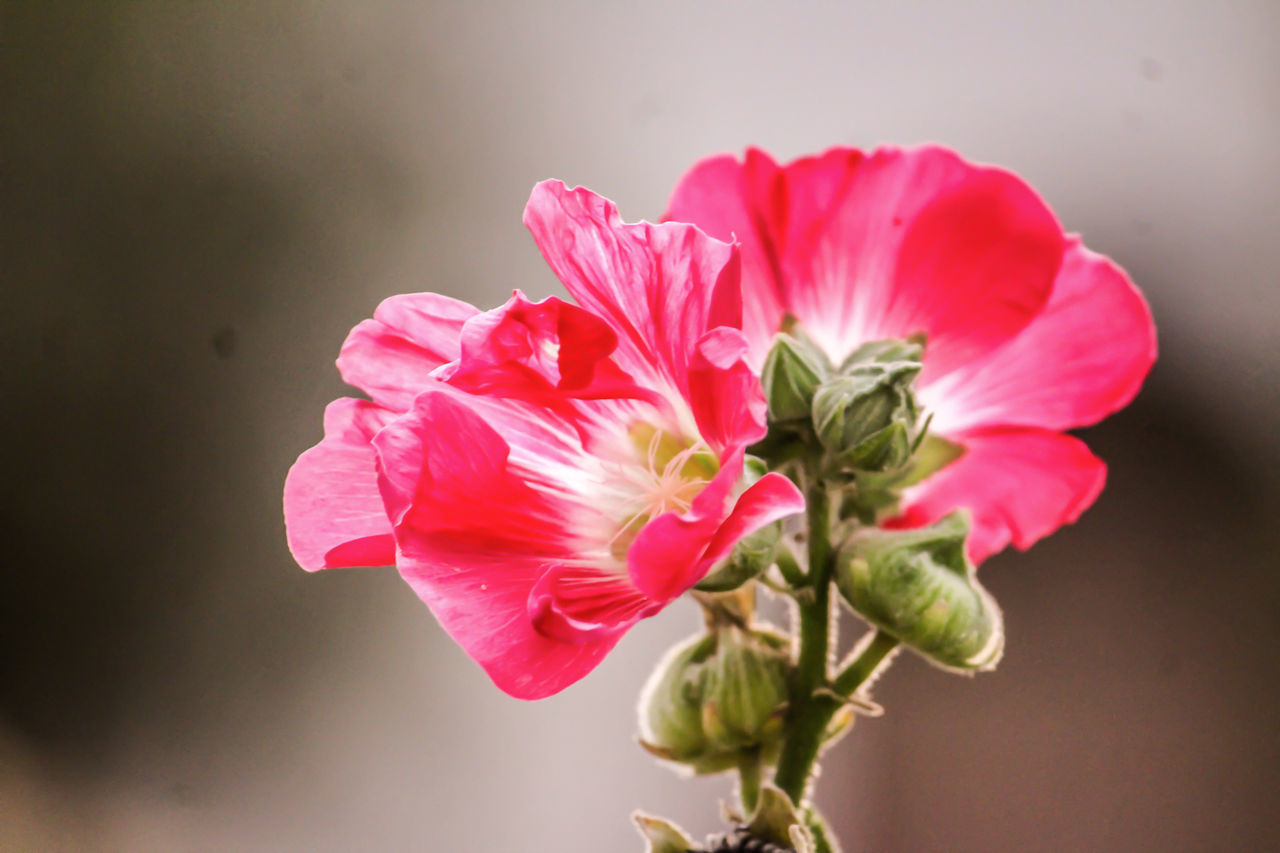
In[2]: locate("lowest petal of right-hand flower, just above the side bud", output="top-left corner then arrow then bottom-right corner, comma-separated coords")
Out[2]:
886,428 -> 1107,564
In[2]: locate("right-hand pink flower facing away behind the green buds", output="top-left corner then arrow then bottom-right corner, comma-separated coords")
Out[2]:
667,146 -> 1156,561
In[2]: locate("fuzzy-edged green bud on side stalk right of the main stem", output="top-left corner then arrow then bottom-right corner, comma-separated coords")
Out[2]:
836,512 -> 1005,672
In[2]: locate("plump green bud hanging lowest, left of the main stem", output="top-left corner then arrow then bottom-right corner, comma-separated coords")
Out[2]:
640,626 -> 791,774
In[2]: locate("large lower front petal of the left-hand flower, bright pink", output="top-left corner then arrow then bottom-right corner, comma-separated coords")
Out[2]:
374,389 -> 621,699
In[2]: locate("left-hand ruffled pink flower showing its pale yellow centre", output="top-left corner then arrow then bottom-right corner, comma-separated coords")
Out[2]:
284,182 -> 803,699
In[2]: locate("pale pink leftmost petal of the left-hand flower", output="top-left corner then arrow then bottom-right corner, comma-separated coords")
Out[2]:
284,398 -> 396,571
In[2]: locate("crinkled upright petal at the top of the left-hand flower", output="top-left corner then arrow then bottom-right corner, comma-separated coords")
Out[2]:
525,181 -> 742,400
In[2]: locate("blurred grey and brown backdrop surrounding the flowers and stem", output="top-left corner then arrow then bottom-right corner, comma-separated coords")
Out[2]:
0,0 -> 1280,852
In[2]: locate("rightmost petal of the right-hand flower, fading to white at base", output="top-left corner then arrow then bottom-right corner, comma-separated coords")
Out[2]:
920,241 -> 1156,432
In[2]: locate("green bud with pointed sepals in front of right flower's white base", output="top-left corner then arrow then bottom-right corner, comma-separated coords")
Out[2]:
813,361 -> 924,471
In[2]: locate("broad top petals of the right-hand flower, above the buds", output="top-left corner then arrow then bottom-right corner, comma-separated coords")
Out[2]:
668,146 -> 1062,371
